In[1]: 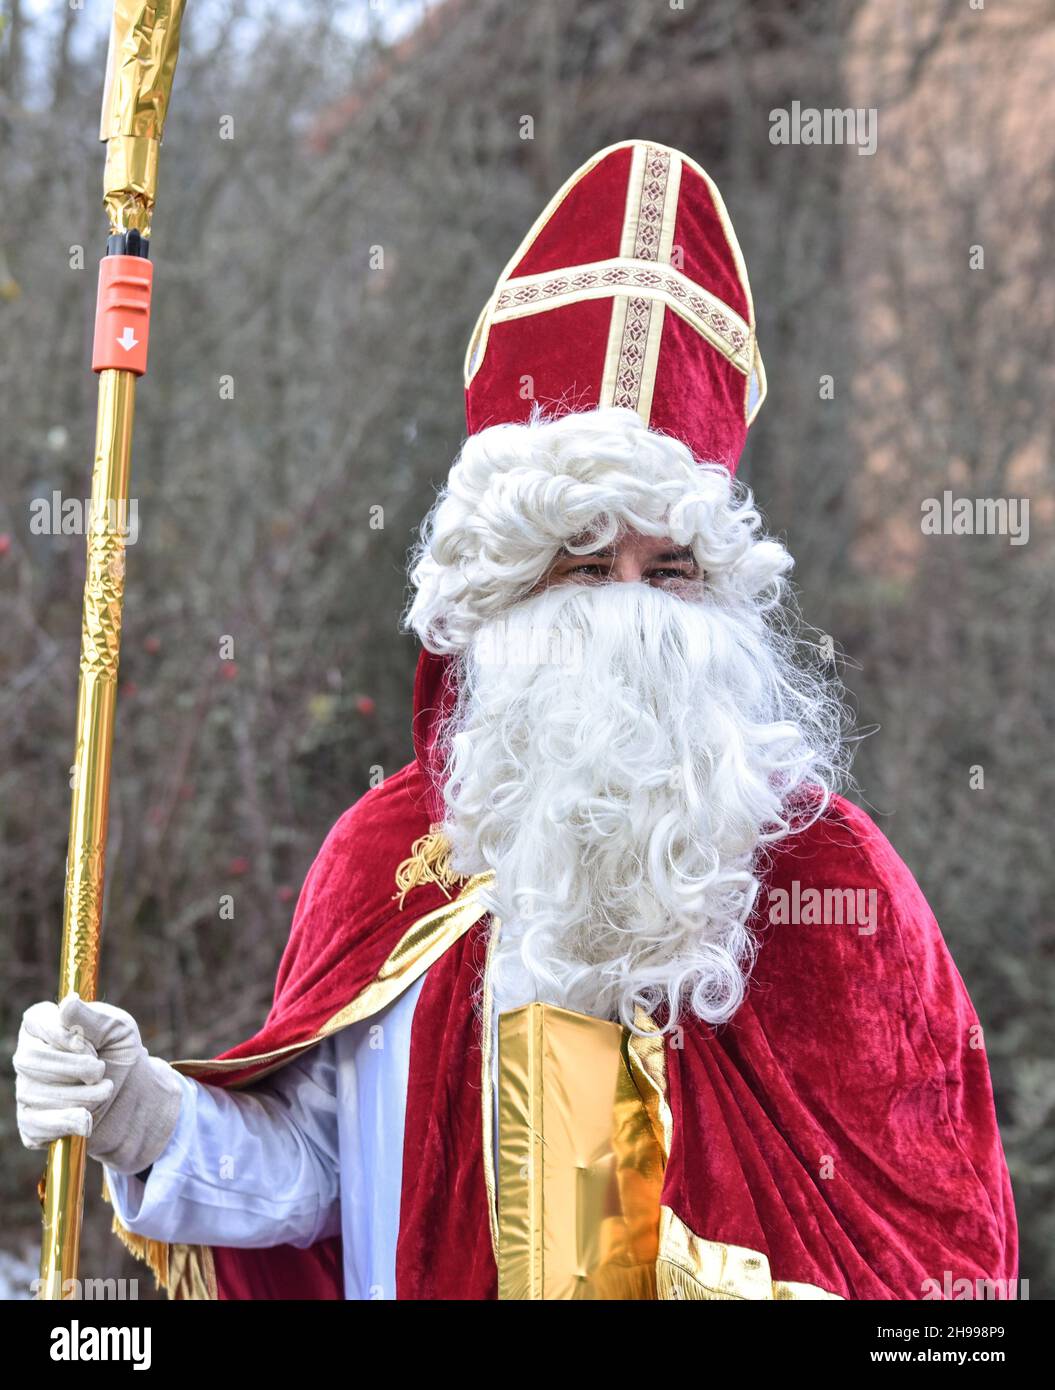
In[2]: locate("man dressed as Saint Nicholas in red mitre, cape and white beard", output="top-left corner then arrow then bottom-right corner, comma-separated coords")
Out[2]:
15,140 -> 1017,1300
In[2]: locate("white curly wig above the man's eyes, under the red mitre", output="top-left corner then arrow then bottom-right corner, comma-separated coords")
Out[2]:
407,406 -> 792,653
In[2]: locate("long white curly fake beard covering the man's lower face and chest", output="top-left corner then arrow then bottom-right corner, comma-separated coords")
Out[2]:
445,584 -> 830,1029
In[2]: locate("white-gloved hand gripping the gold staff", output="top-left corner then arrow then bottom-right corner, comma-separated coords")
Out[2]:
14,994 -> 182,1173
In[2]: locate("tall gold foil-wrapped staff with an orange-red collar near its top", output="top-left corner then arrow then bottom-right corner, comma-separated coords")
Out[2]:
39,0 -> 183,1298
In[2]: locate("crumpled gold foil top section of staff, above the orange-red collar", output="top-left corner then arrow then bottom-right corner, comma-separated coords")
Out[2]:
99,0 -> 185,236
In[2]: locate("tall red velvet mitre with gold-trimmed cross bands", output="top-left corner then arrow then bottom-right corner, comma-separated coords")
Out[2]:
466,140 -> 766,473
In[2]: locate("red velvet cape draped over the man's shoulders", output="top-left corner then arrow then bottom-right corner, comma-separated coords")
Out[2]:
181,657 -> 1017,1300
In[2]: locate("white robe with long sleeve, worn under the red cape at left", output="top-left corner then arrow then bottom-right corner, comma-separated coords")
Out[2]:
106,976 -> 442,1300
